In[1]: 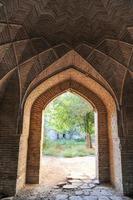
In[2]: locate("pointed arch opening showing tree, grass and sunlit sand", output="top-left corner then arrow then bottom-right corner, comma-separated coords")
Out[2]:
40,89 -> 98,187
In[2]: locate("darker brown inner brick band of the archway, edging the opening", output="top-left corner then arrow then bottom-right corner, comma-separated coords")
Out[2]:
26,80 -> 110,183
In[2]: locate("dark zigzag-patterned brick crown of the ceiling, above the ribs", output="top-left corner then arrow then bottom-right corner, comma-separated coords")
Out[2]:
1,0 -> 133,45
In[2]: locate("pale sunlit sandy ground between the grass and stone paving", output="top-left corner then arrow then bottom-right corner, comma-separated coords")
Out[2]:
41,156 -> 96,187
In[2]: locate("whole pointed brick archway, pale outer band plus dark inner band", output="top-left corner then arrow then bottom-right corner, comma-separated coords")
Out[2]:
16,69 -> 122,194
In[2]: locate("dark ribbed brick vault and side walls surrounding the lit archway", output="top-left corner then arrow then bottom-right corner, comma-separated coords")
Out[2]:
0,0 -> 133,197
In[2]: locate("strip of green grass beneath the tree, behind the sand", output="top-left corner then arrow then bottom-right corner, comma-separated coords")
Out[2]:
43,140 -> 95,158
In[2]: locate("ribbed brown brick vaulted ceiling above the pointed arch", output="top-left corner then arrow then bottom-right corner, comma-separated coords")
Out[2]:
0,0 -> 133,105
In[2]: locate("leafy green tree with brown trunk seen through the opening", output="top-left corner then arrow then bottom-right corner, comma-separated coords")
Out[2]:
45,92 -> 94,148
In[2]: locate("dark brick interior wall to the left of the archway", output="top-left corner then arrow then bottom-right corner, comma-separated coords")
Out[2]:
0,70 -> 20,195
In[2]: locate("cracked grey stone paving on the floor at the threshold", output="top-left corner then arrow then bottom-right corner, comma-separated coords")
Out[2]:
3,176 -> 130,200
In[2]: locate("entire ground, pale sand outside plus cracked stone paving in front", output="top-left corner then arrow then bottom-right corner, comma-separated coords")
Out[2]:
11,156 -> 130,200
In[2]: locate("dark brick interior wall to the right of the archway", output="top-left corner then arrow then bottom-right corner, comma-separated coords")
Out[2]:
121,73 -> 133,196
